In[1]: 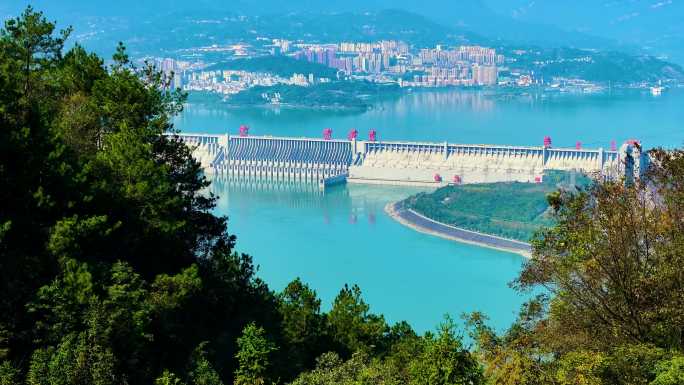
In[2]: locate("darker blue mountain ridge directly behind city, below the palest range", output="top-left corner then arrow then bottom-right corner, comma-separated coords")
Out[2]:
6,7 -> 489,56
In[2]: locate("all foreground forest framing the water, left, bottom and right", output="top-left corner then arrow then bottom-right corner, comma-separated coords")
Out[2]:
0,8 -> 684,385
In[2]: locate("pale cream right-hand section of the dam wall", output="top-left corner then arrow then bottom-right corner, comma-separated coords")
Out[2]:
348,142 -> 620,185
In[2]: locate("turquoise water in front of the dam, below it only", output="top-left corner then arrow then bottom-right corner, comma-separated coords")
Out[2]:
213,181 -> 524,332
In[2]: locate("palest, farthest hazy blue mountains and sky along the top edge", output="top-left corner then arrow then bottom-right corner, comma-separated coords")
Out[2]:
5,0 -> 684,61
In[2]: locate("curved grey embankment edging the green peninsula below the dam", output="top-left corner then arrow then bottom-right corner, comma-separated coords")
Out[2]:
385,202 -> 531,258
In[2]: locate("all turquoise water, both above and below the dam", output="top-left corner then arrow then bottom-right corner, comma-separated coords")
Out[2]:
175,89 -> 684,332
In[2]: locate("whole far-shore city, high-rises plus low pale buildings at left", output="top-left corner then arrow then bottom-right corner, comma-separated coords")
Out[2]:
154,39 -> 535,95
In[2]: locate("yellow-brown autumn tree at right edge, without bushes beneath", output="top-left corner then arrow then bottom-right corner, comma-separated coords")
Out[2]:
517,148 -> 684,352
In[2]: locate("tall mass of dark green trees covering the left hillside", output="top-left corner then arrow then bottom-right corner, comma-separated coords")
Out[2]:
0,7 -> 260,384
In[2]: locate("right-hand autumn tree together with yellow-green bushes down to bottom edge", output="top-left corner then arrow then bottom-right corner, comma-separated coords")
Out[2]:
469,150 -> 684,384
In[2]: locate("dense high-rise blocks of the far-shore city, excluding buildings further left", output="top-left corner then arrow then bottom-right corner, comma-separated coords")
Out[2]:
280,40 -> 505,87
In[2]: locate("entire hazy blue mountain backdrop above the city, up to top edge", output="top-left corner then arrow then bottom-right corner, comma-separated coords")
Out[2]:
0,0 -> 684,82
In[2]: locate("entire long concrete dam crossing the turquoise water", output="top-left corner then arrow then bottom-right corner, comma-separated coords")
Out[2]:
171,126 -> 648,189
